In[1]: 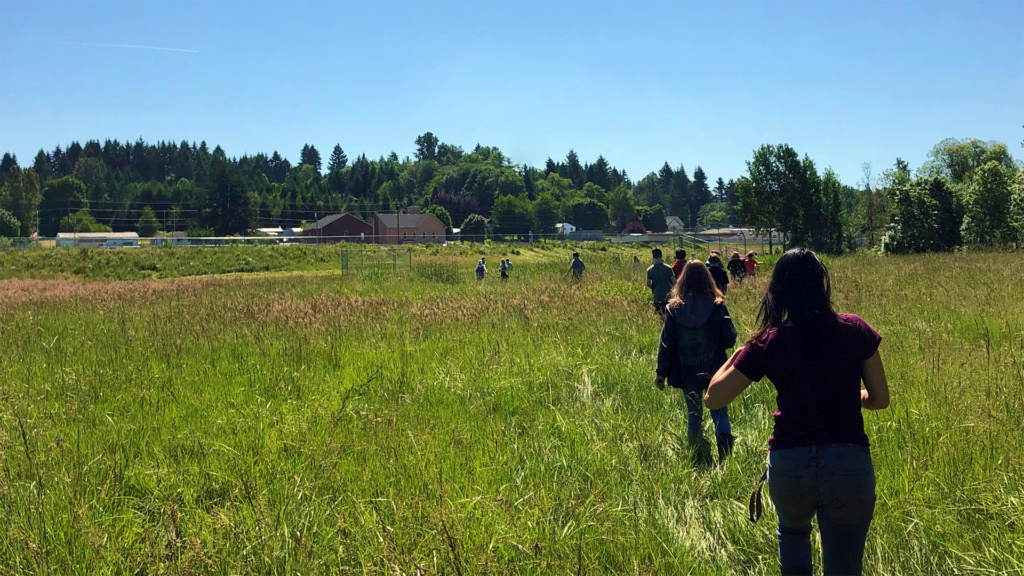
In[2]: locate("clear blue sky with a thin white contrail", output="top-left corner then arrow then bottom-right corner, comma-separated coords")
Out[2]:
0,0 -> 1024,183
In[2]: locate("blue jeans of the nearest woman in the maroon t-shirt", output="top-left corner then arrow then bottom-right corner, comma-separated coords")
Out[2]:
768,444 -> 874,576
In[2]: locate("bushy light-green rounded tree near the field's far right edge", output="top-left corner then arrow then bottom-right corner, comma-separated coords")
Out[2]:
963,161 -> 1015,245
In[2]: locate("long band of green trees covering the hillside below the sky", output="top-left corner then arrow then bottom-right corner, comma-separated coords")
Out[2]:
0,132 -> 1024,253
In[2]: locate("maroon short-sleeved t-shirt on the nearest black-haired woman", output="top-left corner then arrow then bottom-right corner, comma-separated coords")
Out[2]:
733,314 -> 882,450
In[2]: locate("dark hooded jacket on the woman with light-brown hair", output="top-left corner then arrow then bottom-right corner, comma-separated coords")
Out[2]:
657,294 -> 736,390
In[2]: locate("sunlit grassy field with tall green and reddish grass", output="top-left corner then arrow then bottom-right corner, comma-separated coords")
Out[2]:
0,247 -> 1024,575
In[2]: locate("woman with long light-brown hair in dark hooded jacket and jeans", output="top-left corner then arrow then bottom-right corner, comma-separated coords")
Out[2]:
654,260 -> 736,459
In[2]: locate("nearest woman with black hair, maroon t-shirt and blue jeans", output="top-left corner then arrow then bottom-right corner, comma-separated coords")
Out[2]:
705,248 -> 889,576
